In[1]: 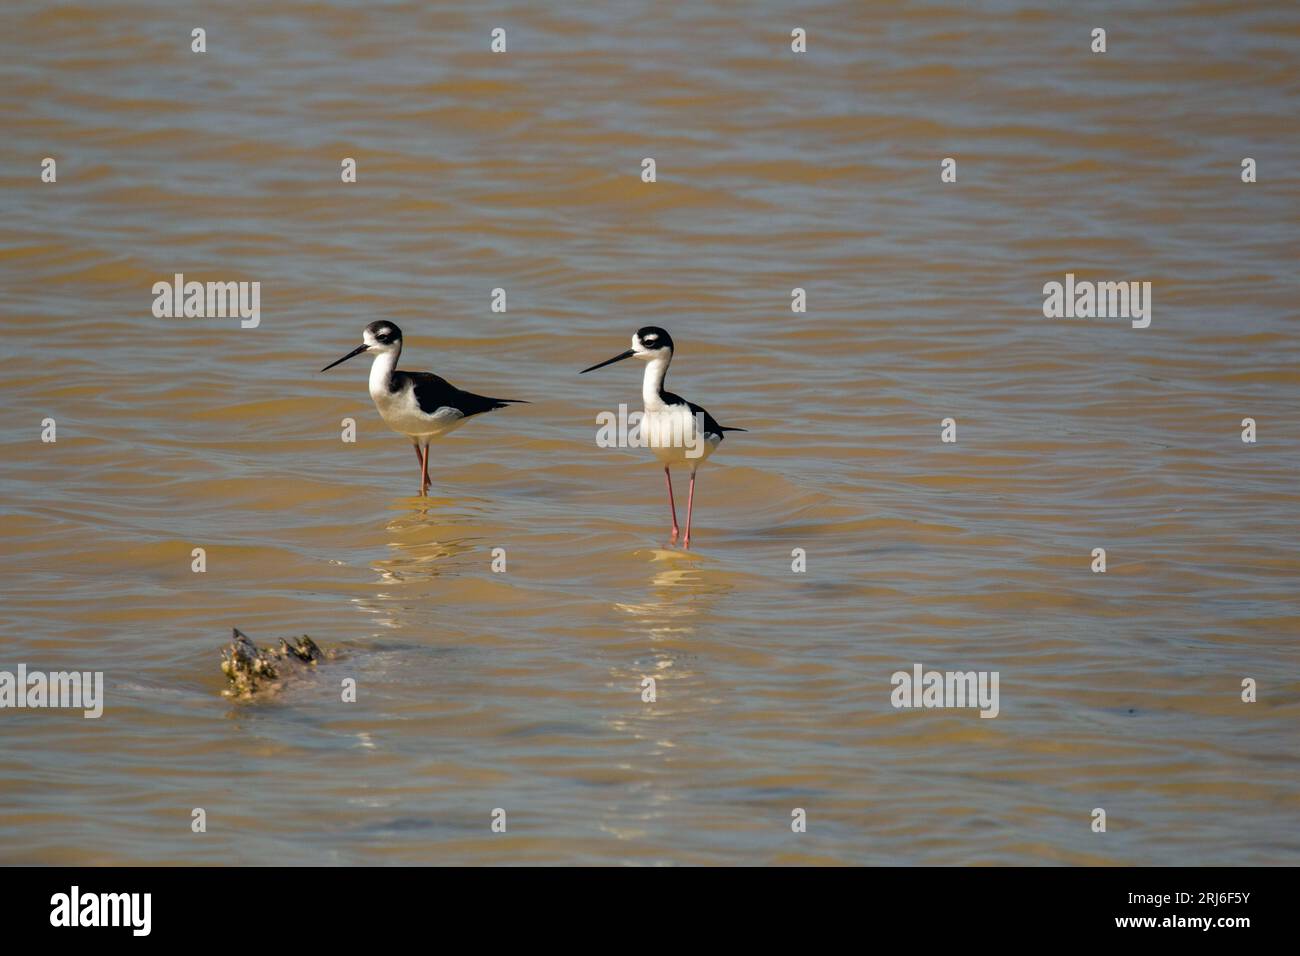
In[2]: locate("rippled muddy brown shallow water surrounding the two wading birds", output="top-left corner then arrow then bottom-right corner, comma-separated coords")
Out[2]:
0,3 -> 1300,865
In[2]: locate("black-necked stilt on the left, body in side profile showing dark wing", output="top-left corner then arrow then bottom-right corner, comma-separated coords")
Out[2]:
321,321 -> 528,494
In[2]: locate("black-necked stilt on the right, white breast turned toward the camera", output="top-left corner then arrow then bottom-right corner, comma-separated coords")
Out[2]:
580,325 -> 745,548
